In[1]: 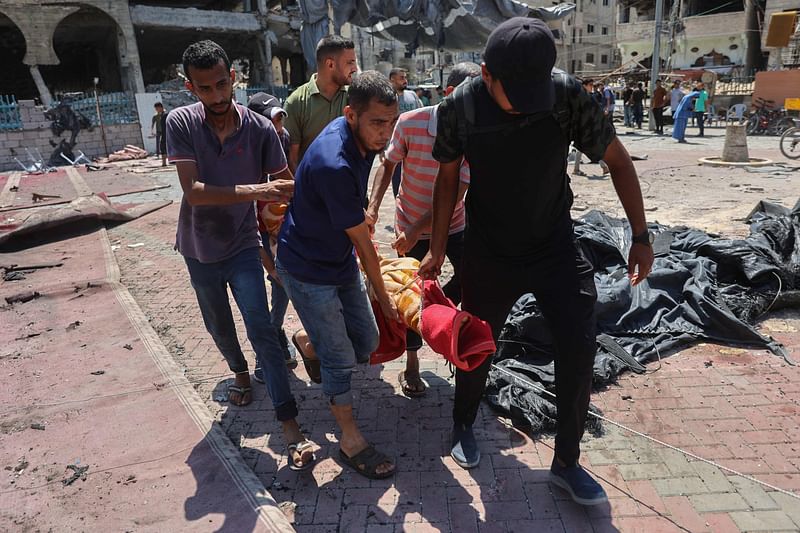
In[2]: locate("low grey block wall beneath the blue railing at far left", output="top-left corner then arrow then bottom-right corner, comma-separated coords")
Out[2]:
0,100 -> 143,172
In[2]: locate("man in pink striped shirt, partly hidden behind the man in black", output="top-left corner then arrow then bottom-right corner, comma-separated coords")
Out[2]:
367,63 -> 481,397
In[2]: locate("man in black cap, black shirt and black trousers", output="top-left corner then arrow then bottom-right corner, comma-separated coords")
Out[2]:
419,17 -> 653,505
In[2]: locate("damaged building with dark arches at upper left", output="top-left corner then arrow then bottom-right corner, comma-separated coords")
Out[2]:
0,0 -> 306,105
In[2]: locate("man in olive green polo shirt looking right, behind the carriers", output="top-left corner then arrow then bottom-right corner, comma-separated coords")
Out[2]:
283,35 -> 358,173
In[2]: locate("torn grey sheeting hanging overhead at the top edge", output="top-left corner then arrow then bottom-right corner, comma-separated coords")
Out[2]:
299,0 -> 576,70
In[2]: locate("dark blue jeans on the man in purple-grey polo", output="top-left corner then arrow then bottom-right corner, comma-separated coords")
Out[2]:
184,248 -> 297,421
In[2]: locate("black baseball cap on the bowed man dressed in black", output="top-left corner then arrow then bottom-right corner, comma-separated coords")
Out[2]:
483,17 -> 556,113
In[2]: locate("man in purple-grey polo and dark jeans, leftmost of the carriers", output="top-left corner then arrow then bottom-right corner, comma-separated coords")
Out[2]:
166,41 -> 314,470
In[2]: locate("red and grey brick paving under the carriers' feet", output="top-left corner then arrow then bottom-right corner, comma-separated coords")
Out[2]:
109,136 -> 800,533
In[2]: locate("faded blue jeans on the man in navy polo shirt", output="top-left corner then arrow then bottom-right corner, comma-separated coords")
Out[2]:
277,263 -> 379,405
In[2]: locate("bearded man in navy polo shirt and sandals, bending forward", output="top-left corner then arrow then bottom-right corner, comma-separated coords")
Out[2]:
276,71 -> 399,478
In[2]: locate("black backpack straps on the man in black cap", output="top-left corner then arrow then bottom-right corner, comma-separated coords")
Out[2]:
453,69 -> 583,147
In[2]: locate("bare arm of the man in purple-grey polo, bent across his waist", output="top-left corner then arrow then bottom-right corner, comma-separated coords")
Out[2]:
176,161 -> 294,206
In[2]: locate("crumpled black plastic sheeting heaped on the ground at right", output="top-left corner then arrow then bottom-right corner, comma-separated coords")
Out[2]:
486,200 -> 800,429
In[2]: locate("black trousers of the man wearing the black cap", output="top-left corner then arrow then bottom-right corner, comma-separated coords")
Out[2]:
453,218 -> 597,465
